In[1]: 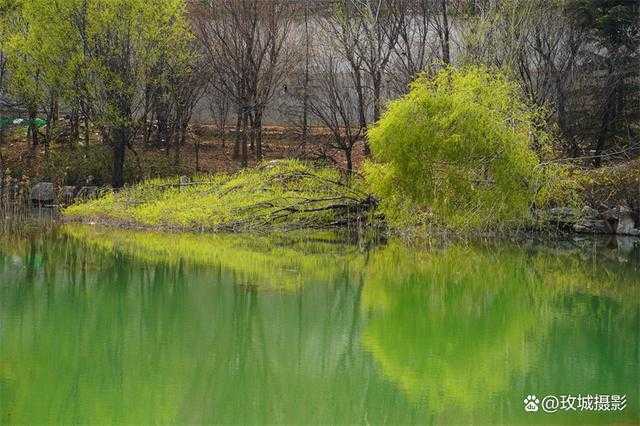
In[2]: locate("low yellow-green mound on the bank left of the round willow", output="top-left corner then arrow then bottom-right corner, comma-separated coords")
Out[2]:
63,160 -> 375,231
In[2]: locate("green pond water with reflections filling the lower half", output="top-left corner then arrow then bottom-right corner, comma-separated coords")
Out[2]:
0,226 -> 640,424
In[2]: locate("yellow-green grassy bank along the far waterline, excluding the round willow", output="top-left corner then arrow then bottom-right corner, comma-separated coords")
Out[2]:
63,155 -> 639,239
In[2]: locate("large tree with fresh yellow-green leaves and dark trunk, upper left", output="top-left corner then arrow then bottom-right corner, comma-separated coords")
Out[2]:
0,0 -> 196,186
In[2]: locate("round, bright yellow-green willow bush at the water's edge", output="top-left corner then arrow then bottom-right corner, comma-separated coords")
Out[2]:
365,67 -> 548,228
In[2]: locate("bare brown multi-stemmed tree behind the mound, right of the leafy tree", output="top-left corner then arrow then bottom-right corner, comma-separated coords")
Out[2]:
195,0 -> 296,167
